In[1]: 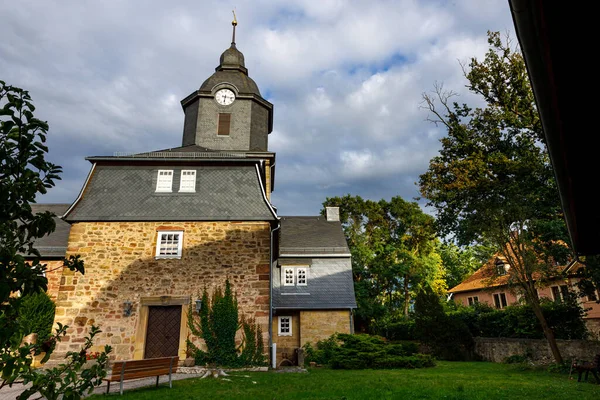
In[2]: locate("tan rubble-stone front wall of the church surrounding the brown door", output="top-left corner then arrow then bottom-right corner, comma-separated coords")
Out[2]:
55,222 -> 270,360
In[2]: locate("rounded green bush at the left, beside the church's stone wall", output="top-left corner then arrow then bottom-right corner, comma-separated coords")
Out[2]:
18,292 -> 56,343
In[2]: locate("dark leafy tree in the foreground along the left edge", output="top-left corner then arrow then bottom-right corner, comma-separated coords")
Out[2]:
0,81 -> 110,400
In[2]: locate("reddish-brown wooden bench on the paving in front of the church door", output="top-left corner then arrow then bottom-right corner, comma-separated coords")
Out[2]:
105,356 -> 179,394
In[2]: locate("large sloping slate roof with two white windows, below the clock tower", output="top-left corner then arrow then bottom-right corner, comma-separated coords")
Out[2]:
65,163 -> 275,222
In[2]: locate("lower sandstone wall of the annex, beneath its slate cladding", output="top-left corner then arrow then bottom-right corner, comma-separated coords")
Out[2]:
300,310 -> 350,347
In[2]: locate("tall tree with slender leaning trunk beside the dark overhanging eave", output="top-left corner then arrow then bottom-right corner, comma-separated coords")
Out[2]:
419,32 -> 572,362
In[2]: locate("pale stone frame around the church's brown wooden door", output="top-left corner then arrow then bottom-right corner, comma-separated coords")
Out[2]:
133,296 -> 190,360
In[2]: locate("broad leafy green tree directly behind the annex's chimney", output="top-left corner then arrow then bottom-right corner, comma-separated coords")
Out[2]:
322,195 -> 446,325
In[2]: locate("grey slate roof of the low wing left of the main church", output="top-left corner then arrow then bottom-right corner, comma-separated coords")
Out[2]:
31,204 -> 71,257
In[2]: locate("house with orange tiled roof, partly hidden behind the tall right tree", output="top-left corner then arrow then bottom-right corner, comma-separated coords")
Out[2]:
448,256 -> 600,335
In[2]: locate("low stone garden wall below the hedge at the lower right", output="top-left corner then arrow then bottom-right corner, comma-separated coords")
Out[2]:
475,338 -> 600,364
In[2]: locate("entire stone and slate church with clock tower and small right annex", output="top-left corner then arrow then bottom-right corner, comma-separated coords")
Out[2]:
49,21 -> 356,366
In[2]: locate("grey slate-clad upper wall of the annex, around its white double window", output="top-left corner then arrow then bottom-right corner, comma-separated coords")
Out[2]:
273,257 -> 356,310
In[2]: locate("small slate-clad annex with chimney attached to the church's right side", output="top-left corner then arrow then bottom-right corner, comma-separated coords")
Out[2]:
272,214 -> 356,364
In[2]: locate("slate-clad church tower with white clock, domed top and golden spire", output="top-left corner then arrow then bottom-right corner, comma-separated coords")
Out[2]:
181,14 -> 273,152
